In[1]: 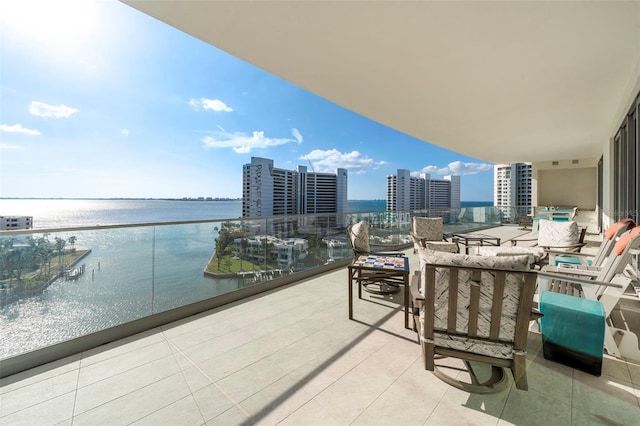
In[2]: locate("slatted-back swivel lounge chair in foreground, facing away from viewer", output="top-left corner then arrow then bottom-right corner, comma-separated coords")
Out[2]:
411,250 -> 536,393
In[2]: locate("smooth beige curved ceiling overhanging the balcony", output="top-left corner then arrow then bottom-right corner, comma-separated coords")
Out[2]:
122,0 -> 640,163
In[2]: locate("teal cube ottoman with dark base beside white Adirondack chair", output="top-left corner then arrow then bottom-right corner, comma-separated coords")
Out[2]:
540,291 -> 606,376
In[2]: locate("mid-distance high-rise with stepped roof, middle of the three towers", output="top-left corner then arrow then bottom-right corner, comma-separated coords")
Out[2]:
387,169 -> 460,211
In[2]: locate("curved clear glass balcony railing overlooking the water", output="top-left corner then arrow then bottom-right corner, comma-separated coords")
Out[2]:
0,207 -> 505,366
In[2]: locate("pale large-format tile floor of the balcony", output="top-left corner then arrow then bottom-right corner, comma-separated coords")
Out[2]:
0,231 -> 640,425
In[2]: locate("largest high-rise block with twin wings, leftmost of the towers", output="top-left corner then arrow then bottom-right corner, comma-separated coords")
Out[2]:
242,157 -> 347,217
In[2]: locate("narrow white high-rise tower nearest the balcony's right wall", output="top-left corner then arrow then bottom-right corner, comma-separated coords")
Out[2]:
493,163 -> 531,219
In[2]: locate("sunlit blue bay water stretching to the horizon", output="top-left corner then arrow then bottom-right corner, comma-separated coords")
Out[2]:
0,199 -> 386,359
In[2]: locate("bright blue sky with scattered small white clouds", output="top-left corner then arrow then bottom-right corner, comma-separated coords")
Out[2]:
0,0 -> 493,201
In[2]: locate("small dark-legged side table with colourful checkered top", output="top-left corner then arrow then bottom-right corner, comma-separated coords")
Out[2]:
347,255 -> 409,328
